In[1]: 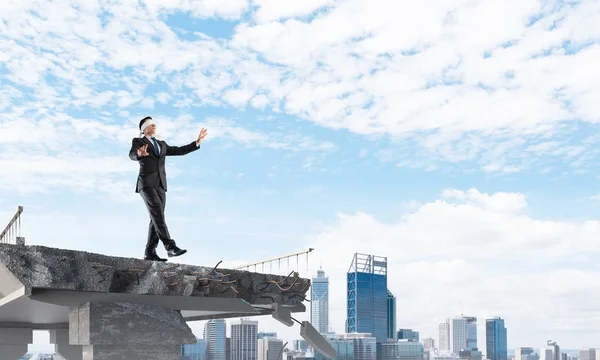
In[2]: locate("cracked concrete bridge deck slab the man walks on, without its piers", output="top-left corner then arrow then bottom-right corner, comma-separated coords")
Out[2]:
0,244 -> 310,328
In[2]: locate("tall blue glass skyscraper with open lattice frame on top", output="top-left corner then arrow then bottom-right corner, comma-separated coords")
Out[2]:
346,253 -> 388,342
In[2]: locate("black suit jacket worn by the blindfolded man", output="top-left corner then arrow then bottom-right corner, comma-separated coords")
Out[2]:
129,136 -> 198,193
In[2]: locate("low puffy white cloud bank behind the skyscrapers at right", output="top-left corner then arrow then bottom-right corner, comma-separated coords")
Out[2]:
300,189 -> 600,348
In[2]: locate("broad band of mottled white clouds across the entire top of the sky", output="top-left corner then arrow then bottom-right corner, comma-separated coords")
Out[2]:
0,0 -> 600,173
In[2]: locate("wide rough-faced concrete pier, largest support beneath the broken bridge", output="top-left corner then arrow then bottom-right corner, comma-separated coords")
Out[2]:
69,303 -> 196,360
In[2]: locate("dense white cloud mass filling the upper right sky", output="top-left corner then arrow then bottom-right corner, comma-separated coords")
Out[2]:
233,0 -> 600,172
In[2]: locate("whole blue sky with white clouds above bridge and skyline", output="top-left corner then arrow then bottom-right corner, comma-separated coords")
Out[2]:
0,0 -> 600,354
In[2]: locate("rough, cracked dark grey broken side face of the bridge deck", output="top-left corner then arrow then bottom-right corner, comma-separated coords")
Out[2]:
0,244 -> 310,305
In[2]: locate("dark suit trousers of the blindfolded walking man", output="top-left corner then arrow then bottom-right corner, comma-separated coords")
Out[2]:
140,185 -> 175,250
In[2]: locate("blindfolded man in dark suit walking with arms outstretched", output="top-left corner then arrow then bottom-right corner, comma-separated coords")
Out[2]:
129,116 -> 207,261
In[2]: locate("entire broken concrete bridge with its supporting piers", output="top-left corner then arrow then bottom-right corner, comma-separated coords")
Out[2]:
0,244 -> 310,360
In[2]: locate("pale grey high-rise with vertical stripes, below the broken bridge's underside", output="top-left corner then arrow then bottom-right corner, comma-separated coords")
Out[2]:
227,319 -> 258,360
